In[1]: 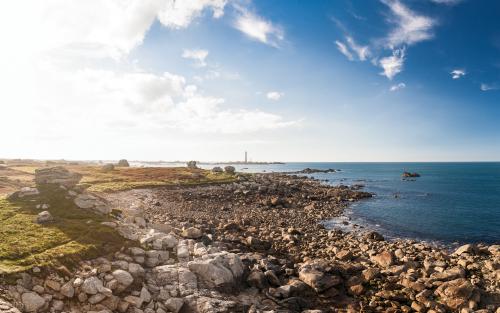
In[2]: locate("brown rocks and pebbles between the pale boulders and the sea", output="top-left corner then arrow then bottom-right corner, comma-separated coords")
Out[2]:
100,174 -> 500,313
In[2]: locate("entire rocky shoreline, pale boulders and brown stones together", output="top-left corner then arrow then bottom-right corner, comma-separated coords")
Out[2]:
0,169 -> 500,313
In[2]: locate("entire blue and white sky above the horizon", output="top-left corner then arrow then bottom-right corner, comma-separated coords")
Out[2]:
0,0 -> 500,162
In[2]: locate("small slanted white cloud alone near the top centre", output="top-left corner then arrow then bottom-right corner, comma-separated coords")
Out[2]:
234,8 -> 285,47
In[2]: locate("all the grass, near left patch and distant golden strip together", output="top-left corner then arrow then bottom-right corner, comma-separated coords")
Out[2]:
0,161 -> 236,275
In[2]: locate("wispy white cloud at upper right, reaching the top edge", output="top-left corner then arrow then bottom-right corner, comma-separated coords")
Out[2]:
382,0 -> 436,48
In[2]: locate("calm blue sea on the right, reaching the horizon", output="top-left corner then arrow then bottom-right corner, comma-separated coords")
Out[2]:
135,162 -> 500,244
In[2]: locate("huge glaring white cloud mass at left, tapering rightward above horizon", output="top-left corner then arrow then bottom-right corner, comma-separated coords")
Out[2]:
0,0 -> 298,150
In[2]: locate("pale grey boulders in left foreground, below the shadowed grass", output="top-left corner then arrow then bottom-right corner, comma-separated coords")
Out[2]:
0,224 -> 254,313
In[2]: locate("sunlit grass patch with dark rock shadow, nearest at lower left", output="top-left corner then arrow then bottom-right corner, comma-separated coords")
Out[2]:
0,185 -> 128,274
